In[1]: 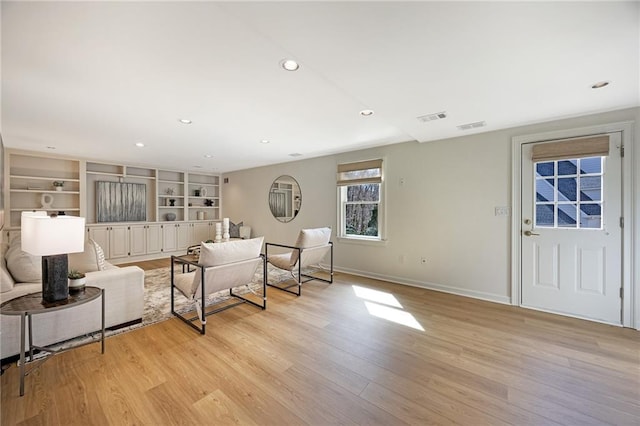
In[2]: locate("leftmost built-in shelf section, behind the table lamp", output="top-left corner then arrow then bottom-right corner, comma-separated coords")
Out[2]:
5,152 -> 81,227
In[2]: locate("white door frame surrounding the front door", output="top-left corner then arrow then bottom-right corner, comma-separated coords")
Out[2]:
511,121 -> 640,329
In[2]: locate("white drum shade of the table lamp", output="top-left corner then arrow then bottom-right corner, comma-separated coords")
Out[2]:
20,212 -> 85,256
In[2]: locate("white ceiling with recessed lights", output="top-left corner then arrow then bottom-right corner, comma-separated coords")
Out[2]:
1,1 -> 640,173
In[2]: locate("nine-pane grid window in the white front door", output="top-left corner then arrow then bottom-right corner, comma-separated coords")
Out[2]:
535,156 -> 605,229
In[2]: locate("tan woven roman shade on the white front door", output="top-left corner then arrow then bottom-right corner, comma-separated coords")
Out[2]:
531,135 -> 609,162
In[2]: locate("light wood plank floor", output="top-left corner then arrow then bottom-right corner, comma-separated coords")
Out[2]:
1,264 -> 640,426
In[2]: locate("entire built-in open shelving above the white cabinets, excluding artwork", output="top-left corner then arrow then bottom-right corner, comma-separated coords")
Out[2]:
4,150 -> 221,233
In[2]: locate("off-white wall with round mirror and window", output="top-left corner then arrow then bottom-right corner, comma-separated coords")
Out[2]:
222,108 -> 640,310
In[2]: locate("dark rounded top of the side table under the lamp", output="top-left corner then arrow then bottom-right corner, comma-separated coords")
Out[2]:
0,286 -> 102,315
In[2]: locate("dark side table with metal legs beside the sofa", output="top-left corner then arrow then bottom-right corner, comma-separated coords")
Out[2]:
0,286 -> 105,396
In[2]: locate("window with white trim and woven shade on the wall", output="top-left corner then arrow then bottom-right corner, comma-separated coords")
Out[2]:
337,159 -> 384,240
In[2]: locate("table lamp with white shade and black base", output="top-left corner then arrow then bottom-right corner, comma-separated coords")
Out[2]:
21,211 -> 85,302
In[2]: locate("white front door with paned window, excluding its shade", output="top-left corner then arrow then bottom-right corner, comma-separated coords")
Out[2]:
521,133 -> 622,324
